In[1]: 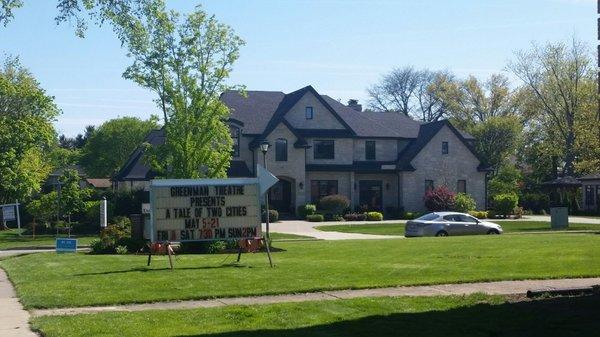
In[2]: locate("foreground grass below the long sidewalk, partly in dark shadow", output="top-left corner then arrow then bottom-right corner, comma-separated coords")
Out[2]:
32,294 -> 600,337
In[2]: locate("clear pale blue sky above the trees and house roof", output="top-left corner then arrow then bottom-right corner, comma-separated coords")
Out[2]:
0,0 -> 598,136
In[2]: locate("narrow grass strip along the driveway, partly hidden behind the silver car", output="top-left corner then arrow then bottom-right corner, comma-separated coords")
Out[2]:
316,220 -> 600,236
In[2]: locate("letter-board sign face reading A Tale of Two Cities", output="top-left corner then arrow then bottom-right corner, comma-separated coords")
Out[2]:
150,178 -> 276,242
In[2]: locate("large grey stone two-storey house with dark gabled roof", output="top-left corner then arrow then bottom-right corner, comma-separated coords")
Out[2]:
113,86 -> 487,213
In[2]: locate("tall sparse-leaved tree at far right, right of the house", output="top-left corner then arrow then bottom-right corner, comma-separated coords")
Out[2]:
509,39 -> 600,175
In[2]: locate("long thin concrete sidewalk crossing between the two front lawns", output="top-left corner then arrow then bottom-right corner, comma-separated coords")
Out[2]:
31,278 -> 600,316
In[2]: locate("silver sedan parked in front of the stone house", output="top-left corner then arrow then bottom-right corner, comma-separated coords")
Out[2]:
404,212 -> 502,237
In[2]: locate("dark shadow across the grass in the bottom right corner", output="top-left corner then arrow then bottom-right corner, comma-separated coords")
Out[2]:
172,296 -> 600,337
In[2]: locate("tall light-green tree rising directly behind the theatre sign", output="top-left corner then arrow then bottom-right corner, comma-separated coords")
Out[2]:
111,0 -> 243,178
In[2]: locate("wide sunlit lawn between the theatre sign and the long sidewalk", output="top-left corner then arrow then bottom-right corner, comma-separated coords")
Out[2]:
0,234 -> 600,308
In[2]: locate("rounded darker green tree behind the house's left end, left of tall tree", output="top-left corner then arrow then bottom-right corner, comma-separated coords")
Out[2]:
81,116 -> 158,177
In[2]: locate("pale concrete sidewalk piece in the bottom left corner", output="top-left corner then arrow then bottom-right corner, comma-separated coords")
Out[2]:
0,268 -> 38,337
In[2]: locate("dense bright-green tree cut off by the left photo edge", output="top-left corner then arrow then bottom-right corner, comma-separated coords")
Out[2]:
0,58 -> 59,203
